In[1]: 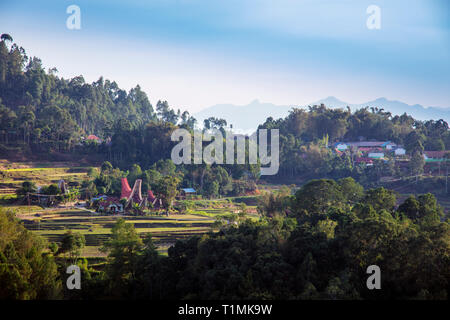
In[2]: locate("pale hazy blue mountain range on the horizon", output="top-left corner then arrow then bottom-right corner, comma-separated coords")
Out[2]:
194,97 -> 450,132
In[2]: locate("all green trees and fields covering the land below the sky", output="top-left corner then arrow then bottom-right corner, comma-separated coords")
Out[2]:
0,35 -> 450,300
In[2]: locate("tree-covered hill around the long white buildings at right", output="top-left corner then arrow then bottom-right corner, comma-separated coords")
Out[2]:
260,104 -> 450,182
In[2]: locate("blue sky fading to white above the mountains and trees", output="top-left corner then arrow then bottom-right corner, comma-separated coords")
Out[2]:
0,0 -> 450,112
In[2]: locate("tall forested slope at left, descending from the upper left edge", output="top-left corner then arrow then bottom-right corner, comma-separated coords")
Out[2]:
0,34 -> 162,148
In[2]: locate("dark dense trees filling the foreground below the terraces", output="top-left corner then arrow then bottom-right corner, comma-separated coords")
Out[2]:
0,178 -> 450,299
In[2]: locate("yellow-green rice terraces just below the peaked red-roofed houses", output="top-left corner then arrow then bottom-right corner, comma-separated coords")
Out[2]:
7,199 -> 259,257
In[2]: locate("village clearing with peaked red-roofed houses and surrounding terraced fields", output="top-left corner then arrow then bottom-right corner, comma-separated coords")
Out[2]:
0,160 -> 259,261
